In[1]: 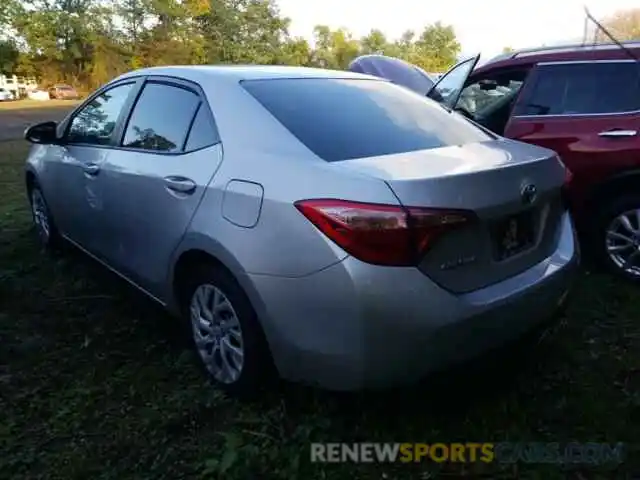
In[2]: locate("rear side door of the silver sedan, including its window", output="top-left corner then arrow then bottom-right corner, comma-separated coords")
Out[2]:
100,77 -> 222,296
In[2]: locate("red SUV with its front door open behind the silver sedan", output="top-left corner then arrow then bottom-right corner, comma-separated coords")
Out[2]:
400,42 -> 640,281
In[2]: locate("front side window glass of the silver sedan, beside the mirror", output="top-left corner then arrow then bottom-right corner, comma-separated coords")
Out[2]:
67,83 -> 133,145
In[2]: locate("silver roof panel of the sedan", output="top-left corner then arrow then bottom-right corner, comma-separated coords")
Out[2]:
116,65 -> 380,82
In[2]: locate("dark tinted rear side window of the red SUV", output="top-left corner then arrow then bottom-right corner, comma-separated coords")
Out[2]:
517,62 -> 640,115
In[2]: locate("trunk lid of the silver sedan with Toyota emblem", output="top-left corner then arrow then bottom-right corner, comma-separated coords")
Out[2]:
339,139 -> 566,293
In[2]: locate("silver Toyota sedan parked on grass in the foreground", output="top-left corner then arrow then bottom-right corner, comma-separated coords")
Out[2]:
25,66 -> 579,392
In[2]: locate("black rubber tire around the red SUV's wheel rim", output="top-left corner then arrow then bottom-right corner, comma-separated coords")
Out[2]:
589,193 -> 640,283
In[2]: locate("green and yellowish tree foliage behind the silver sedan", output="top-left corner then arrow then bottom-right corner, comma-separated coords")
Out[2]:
0,0 -> 460,89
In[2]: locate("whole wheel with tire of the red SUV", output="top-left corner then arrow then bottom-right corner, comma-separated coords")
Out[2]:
594,194 -> 640,282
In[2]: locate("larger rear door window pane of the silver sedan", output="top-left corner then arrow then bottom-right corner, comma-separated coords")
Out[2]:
122,83 -> 200,152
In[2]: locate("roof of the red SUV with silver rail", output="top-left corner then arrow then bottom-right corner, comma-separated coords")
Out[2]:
474,41 -> 640,74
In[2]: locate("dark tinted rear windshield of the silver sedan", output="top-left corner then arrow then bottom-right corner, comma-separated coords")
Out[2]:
242,78 -> 494,162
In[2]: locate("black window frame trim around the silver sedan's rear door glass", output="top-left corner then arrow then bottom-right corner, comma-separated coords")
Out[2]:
111,75 -> 221,157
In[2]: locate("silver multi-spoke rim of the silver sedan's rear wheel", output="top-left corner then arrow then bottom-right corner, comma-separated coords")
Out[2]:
190,284 -> 244,384
